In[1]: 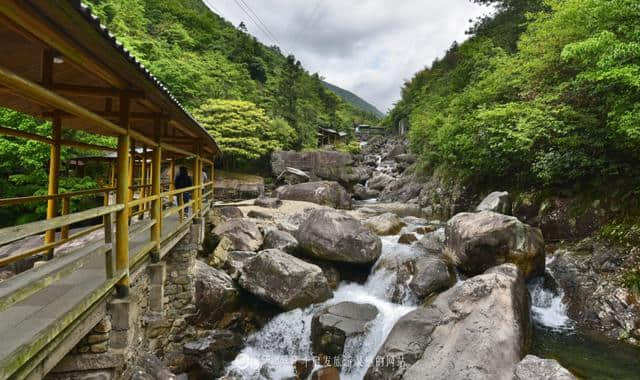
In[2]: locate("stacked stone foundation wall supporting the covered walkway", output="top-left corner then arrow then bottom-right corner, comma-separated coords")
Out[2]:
46,219 -> 204,380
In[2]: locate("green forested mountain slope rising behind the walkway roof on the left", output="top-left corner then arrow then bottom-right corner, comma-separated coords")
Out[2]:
82,0 -> 374,153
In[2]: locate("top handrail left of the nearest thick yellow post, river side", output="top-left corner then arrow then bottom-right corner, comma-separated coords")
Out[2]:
0,204 -> 124,246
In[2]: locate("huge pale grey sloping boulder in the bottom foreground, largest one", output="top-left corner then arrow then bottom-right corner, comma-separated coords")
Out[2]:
365,264 -> 529,380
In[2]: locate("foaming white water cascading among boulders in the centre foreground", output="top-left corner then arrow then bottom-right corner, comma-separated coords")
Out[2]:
227,236 -> 416,380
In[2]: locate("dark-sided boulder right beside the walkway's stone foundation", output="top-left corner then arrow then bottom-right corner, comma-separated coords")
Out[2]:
195,260 -> 240,322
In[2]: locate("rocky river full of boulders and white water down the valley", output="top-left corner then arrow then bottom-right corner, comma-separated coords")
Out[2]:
191,138 -> 640,380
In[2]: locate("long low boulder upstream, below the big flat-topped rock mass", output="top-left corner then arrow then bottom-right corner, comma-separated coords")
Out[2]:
274,181 -> 351,210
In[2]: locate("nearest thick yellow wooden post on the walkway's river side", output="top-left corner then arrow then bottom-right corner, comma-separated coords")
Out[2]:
116,96 -> 131,298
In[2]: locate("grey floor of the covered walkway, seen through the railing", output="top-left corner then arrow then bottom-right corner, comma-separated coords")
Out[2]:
0,215 -> 188,378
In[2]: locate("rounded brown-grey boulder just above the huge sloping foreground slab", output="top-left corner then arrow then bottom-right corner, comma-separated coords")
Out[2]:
444,211 -> 545,280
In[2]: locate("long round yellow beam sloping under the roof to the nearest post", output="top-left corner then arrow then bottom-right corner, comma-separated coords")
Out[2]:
0,65 -> 127,135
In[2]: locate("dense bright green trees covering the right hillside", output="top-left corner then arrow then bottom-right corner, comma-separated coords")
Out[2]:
386,0 -> 640,191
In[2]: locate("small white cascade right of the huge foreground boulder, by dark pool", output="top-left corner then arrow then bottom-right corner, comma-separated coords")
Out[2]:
529,257 -> 573,331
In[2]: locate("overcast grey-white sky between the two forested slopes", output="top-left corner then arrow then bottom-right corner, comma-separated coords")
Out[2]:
206,0 -> 487,112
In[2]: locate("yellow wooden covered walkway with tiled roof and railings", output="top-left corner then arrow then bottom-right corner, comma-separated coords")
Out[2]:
0,0 -> 220,380
